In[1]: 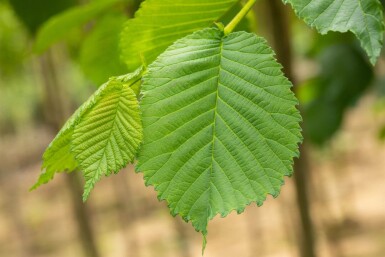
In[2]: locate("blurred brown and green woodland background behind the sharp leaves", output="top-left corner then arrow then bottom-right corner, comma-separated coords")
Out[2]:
0,0 -> 385,257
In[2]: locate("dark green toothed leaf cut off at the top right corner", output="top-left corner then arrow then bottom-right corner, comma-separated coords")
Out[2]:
283,0 -> 384,64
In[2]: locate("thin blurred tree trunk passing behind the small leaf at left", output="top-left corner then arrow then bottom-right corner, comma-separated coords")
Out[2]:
40,49 -> 100,257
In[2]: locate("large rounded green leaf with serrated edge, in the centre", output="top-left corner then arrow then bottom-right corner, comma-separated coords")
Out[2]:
137,28 -> 301,236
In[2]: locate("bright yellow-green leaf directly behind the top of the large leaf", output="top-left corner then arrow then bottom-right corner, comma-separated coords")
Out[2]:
121,0 -> 239,70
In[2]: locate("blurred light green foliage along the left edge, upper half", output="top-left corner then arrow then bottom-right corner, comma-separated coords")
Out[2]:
0,1 -> 39,134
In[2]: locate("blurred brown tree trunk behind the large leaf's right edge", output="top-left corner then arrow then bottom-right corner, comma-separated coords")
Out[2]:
258,0 -> 316,257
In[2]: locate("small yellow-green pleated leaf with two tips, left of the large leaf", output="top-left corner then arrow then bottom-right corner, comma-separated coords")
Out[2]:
31,69 -> 142,199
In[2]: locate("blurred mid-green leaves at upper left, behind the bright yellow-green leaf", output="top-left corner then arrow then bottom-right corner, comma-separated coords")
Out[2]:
34,0 -> 130,86
